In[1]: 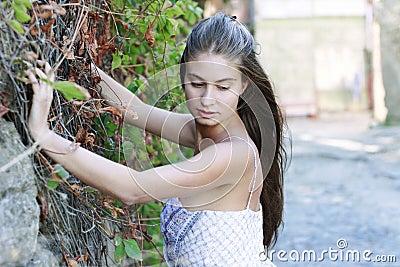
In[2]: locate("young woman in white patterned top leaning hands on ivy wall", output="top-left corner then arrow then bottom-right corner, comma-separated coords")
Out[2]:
27,13 -> 285,266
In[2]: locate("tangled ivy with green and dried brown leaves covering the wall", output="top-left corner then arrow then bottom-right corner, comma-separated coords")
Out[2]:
0,0 -> 202,266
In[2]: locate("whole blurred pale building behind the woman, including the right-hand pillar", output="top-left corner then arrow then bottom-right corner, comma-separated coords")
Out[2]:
204,0 -> 400,122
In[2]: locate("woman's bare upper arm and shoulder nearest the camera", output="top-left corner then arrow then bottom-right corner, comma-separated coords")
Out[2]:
135,135 -> 254,201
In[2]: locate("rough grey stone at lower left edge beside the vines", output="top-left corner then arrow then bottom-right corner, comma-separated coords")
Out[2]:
0,119 -> 56,266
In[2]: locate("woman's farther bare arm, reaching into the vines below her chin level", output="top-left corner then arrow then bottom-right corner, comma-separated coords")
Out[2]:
92,64 -> 195,147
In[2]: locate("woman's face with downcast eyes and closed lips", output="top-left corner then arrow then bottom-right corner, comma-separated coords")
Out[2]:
184,54 -> 247,126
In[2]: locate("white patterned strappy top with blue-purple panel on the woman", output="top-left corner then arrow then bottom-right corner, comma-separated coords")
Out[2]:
161,137 -> 275,267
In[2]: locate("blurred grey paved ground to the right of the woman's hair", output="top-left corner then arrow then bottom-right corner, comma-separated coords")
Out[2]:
273,113 -> 400,266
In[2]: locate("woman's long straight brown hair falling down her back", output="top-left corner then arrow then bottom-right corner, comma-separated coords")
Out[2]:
181,13 -> 286,248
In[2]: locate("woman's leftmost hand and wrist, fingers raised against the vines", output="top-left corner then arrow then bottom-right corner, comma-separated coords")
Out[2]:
26,61 -> 55,143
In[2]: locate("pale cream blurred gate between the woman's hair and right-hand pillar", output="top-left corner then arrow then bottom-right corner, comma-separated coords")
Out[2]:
256,0 -> 371,115
